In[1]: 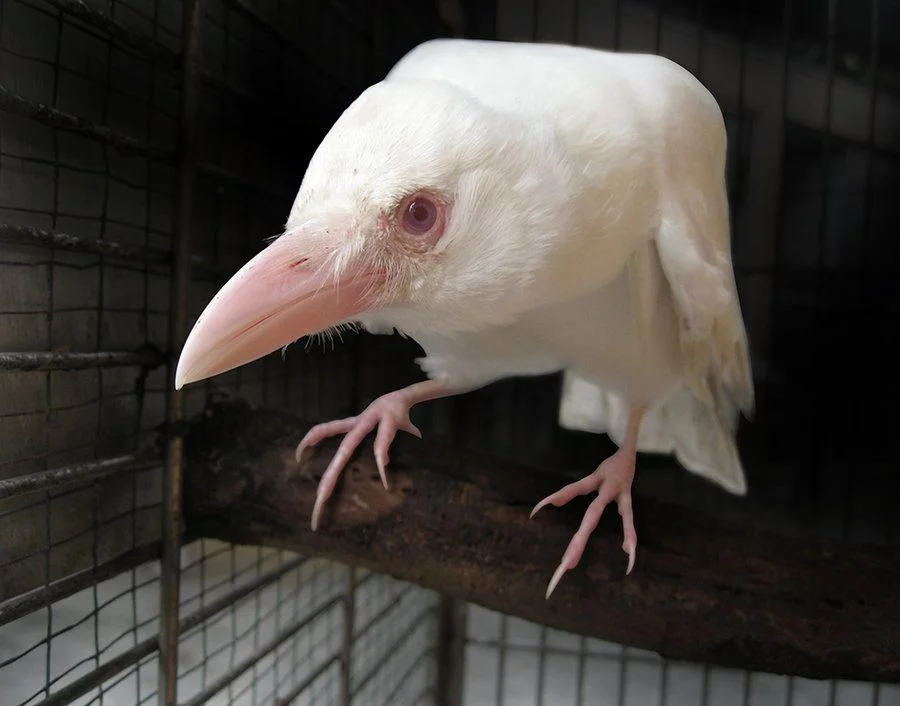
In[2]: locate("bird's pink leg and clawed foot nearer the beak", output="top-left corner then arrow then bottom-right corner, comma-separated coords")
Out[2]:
296,380 -> 458,532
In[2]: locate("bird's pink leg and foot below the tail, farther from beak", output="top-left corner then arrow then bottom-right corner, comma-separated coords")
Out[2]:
531,410 -> 644,598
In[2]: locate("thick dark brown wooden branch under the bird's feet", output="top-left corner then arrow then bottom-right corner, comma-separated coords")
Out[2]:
184,401 -> 900,682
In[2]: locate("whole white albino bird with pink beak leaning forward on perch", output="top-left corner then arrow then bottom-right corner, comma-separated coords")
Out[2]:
176,39 -> 754,597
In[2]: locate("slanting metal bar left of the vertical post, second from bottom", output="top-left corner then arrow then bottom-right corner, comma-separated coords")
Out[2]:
0,542 -> 160,626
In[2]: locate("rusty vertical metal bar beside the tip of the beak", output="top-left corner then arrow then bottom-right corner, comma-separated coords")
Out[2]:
159,0 -> 203,706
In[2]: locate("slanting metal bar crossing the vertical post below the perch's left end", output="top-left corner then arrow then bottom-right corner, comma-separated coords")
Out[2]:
35,543 -> 308,706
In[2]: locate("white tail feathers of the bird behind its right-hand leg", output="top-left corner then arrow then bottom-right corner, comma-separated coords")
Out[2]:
559,371 -> 747,495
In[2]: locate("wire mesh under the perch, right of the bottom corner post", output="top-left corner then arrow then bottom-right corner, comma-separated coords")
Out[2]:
463,606 -> 900,706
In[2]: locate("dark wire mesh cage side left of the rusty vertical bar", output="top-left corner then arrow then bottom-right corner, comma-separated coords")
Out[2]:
0,0 -> 179,704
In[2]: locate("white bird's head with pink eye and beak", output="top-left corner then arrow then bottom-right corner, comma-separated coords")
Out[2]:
176,80 -> 572,389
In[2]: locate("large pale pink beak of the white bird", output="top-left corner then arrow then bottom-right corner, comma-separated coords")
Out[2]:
175,234 -> 378,390
